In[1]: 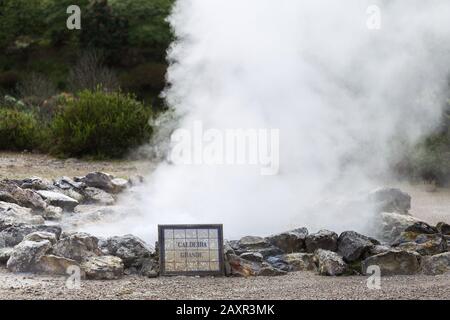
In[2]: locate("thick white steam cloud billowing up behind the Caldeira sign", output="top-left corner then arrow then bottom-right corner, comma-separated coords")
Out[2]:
81,0 -> 450,241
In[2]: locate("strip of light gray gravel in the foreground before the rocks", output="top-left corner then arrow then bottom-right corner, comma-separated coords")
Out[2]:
0,268 -> 450,300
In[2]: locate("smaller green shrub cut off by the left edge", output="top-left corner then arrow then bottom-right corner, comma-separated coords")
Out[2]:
0,109 -> 43,151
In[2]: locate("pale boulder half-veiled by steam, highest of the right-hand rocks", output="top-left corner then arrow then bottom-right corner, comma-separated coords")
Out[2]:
369,188 -> 411,214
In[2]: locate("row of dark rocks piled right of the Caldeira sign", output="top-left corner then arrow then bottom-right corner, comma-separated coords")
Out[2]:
225,188 -> 450,276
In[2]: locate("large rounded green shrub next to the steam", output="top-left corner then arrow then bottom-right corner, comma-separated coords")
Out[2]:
51,89 -> 151,158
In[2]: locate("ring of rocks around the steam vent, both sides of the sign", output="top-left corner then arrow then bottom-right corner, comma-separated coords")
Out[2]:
0,179 -> 450,279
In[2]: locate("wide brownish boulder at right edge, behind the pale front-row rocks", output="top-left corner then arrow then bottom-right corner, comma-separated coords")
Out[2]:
393,231 -> 447,256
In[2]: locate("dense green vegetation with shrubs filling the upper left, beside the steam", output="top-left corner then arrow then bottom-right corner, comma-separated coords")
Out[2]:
0,0 -> 173,157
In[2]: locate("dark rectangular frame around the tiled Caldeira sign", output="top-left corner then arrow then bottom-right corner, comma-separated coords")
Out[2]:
158,224 -> 225,276
